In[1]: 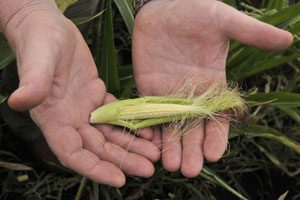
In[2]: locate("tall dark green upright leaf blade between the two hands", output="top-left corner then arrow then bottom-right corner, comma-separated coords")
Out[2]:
99,0 -> 120,97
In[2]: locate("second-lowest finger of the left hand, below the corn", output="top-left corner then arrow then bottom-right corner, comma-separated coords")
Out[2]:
79,125 -> 154,177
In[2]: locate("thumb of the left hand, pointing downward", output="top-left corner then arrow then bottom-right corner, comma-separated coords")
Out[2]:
8,37 -> 59,111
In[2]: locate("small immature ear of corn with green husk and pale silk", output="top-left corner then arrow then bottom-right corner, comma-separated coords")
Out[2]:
90,84 -> 245,130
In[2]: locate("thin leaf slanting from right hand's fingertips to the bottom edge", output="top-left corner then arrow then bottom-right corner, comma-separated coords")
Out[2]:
199,167 -> 247,200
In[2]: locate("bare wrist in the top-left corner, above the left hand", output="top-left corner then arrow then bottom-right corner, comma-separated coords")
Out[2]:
0,0 -> 59,36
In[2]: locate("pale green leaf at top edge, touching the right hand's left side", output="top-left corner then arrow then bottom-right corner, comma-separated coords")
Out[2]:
114,0 -> 134,35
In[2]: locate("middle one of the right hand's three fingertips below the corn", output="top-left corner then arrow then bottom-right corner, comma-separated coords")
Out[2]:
181,124 -> 204,177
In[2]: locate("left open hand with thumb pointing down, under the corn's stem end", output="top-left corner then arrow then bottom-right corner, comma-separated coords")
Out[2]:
2,1 -> 159,187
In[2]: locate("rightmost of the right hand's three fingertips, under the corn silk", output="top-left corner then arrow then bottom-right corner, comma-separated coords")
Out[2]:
203,117 -> 229,162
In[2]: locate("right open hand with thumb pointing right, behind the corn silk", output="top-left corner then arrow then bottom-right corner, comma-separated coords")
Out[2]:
133,0 -> 293,177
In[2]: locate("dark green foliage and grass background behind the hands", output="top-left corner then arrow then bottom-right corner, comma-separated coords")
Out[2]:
0,0 -> 300,200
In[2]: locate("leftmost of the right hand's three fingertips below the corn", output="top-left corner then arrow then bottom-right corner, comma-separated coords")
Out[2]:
162,127 -> 182,172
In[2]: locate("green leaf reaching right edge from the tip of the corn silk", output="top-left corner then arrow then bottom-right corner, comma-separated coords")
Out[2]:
245,92 -> 300,107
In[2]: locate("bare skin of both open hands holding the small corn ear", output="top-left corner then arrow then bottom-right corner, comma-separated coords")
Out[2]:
0,0 -> 292,187
